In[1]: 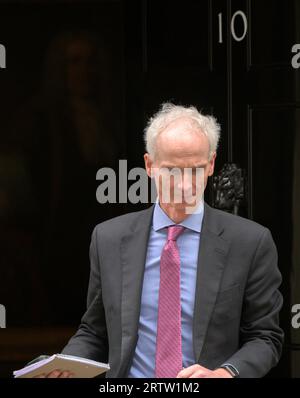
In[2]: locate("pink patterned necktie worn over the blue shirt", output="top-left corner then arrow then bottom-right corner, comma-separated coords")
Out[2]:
155,225 -> 185,377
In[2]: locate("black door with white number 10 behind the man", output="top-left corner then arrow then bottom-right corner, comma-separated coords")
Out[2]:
125,0 -> 300,376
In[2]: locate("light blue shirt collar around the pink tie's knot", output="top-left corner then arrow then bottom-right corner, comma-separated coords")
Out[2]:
152,201 -> 204,233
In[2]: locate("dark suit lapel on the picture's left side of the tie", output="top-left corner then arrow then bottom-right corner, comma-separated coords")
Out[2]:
120,206 -> 153,374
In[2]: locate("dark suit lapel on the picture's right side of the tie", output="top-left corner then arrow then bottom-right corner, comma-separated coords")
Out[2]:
193,204 -> 228,362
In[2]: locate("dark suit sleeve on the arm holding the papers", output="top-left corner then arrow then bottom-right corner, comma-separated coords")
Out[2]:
62,227 -> 108,362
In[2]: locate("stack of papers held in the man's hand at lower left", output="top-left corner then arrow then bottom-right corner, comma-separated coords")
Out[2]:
14,354 -> 109,378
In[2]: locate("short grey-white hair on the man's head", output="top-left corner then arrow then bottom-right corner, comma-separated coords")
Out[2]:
144,102 -> 221,159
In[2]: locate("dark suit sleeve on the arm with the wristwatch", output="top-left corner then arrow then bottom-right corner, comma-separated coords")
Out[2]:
226,229 -> 284,377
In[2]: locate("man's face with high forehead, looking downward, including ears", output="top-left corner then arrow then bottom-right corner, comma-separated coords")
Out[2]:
144,118 -> 215,211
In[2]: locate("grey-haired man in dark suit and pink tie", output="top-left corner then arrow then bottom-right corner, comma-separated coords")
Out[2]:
36,104 -> 283,378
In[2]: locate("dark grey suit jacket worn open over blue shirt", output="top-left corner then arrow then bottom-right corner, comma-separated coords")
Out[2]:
63,204 -> 283,377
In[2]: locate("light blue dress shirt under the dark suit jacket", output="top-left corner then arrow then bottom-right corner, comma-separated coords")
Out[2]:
129,202 -> 204,378
